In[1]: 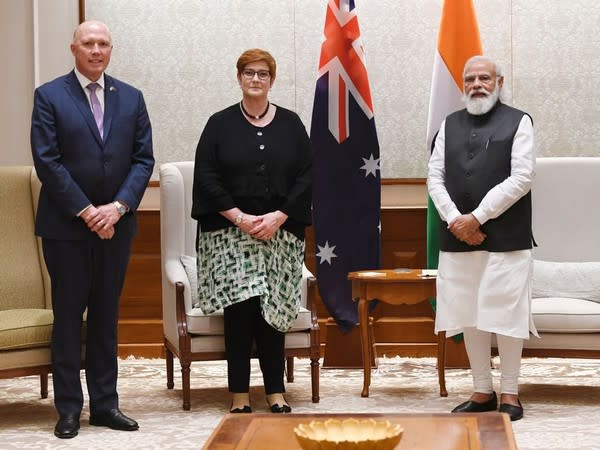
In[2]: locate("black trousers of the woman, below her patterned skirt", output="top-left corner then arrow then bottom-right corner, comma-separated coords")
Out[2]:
223,297 -> 285,395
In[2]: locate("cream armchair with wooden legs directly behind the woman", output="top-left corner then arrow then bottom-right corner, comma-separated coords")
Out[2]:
160,161 -> 320,410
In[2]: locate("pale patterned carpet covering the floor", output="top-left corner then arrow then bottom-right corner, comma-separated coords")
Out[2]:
0,358 -> 600,450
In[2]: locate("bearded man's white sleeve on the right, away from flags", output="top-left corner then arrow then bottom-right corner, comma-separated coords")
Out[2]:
472,114 -> 535,224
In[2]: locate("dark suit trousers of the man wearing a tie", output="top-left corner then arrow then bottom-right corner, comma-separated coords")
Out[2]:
42,233 -> 132,416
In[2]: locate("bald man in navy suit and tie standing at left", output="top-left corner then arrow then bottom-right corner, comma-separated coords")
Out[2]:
31,21 -> 154,438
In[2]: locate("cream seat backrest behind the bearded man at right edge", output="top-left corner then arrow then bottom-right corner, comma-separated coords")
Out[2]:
531,157 -> 600,262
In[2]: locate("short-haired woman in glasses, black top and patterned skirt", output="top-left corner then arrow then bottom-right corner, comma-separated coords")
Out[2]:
192,49 -> 312,413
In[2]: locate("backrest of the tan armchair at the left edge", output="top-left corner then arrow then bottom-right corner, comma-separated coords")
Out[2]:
0,166 -> 49,310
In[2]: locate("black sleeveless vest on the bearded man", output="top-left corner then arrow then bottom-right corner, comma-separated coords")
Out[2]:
440,102 -> 532,252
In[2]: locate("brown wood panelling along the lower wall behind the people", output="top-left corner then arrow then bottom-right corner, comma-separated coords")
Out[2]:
119,207 -> 464,366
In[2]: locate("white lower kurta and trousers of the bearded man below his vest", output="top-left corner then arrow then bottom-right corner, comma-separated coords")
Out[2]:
435,250 -> 538,395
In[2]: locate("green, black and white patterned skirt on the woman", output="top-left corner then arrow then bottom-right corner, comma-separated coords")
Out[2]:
198,227 -> 304,332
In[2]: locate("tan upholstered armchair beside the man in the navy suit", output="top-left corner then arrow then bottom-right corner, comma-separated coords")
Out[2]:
0,166 -> 53,398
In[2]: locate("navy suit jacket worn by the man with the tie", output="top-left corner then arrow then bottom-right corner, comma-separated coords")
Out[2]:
31,71 -> 154,240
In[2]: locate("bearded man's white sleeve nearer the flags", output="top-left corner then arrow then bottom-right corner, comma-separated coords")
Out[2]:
427,120 -> 460,223
